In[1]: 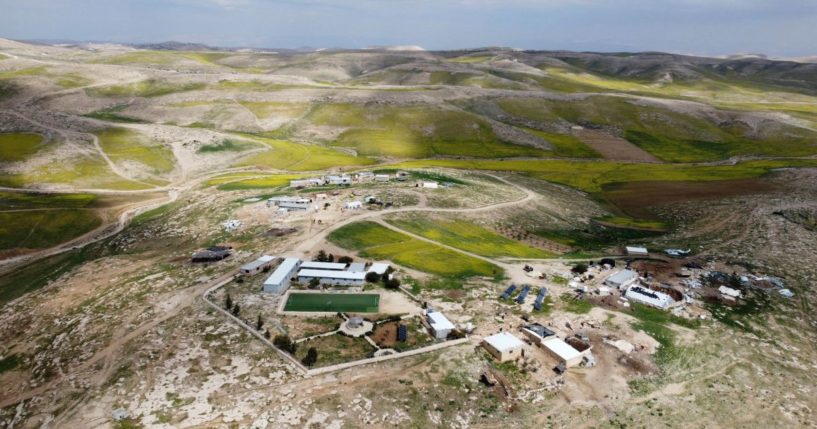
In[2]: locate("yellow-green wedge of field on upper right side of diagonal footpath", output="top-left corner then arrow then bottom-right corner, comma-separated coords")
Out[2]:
388,218 -> 554,258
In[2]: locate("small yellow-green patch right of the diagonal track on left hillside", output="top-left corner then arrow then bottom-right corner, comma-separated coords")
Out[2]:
97,128 -> 175,174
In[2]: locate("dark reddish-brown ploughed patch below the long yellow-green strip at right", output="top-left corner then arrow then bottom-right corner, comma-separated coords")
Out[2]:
603,179 -> 782,219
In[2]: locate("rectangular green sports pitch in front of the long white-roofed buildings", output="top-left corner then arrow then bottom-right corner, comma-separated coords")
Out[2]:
284,293 -> 380,313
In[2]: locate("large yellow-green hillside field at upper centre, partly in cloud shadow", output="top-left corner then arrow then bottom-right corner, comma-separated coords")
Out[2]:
308,104 -> 547,158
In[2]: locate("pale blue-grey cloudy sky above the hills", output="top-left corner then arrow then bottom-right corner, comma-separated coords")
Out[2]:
0,0 -> 817,57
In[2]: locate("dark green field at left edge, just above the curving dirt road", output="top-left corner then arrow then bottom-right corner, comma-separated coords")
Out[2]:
0,209 -> 102,250
